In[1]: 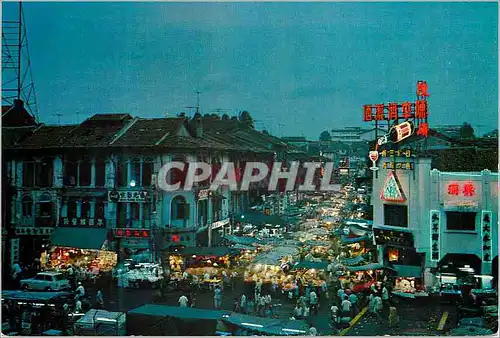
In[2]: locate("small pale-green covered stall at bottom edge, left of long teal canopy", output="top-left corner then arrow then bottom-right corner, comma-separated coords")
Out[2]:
73,309 -> 127,336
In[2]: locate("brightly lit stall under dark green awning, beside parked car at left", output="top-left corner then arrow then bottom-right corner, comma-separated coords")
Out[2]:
40,228 -> 118,280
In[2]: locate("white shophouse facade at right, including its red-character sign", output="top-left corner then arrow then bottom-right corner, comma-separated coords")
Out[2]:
372,158 -> 498,275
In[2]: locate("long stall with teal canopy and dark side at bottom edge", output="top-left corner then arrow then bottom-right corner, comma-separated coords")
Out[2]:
126,304 -> 230,336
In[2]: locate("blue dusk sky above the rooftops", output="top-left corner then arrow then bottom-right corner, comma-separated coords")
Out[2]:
3,2 -> 498,139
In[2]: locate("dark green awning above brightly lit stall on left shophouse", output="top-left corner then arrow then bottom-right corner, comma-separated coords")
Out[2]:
51,227 -> 108,250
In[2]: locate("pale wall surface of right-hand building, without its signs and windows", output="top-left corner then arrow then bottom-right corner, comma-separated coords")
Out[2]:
371,158 -> 498,274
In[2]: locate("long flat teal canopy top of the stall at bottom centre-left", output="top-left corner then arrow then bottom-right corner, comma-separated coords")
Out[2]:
127,304 -> 230,320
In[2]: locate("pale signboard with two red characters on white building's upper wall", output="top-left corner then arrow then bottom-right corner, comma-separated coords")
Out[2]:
441,180 -> 482,210
